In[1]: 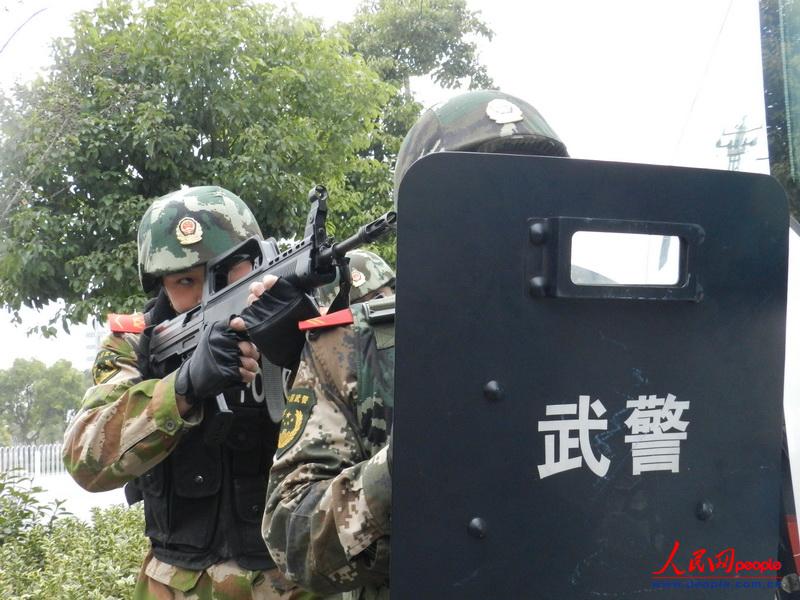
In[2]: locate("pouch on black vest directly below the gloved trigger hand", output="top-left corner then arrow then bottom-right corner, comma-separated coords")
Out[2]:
168,428 -> 222,550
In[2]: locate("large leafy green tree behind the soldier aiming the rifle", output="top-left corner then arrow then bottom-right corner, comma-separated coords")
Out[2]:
0,0 -> 390,327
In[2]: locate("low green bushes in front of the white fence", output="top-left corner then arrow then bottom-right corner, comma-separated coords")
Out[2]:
0,474 -> 148,600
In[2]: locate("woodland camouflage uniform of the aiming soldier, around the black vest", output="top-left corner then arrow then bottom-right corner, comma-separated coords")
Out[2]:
64,334 -> 288,599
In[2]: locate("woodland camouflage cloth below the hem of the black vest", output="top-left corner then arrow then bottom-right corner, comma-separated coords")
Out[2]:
133,552 -> 319,600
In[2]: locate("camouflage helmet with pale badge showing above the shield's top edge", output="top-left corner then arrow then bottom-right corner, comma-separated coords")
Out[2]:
394,90 -> 569,194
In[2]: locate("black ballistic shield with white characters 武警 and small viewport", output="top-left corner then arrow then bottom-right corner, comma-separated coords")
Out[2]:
391,152 -> 788,600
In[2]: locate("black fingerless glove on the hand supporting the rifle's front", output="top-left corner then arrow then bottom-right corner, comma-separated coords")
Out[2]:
241,279 -> 319,369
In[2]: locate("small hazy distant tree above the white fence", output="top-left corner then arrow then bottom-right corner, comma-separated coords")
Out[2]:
0,358 -> 86,444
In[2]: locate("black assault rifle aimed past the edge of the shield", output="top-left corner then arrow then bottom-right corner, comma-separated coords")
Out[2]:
150,185 -> 397,442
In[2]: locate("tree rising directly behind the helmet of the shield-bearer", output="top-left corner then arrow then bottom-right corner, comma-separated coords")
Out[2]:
332,0 -> 494,262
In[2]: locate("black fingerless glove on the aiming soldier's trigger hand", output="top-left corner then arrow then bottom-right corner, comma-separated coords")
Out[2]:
175,321 -> 244,404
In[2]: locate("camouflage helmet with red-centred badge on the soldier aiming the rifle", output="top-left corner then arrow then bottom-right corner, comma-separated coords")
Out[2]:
138,186 -> 262,292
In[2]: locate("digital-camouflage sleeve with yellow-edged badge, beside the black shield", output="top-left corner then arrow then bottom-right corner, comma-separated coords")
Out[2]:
262,328 -> 391,594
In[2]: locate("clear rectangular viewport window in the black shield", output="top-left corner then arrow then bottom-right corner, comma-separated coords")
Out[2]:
570,231 -> 681,286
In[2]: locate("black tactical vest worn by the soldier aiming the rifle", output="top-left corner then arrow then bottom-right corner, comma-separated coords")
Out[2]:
131,312 -> 280,570
